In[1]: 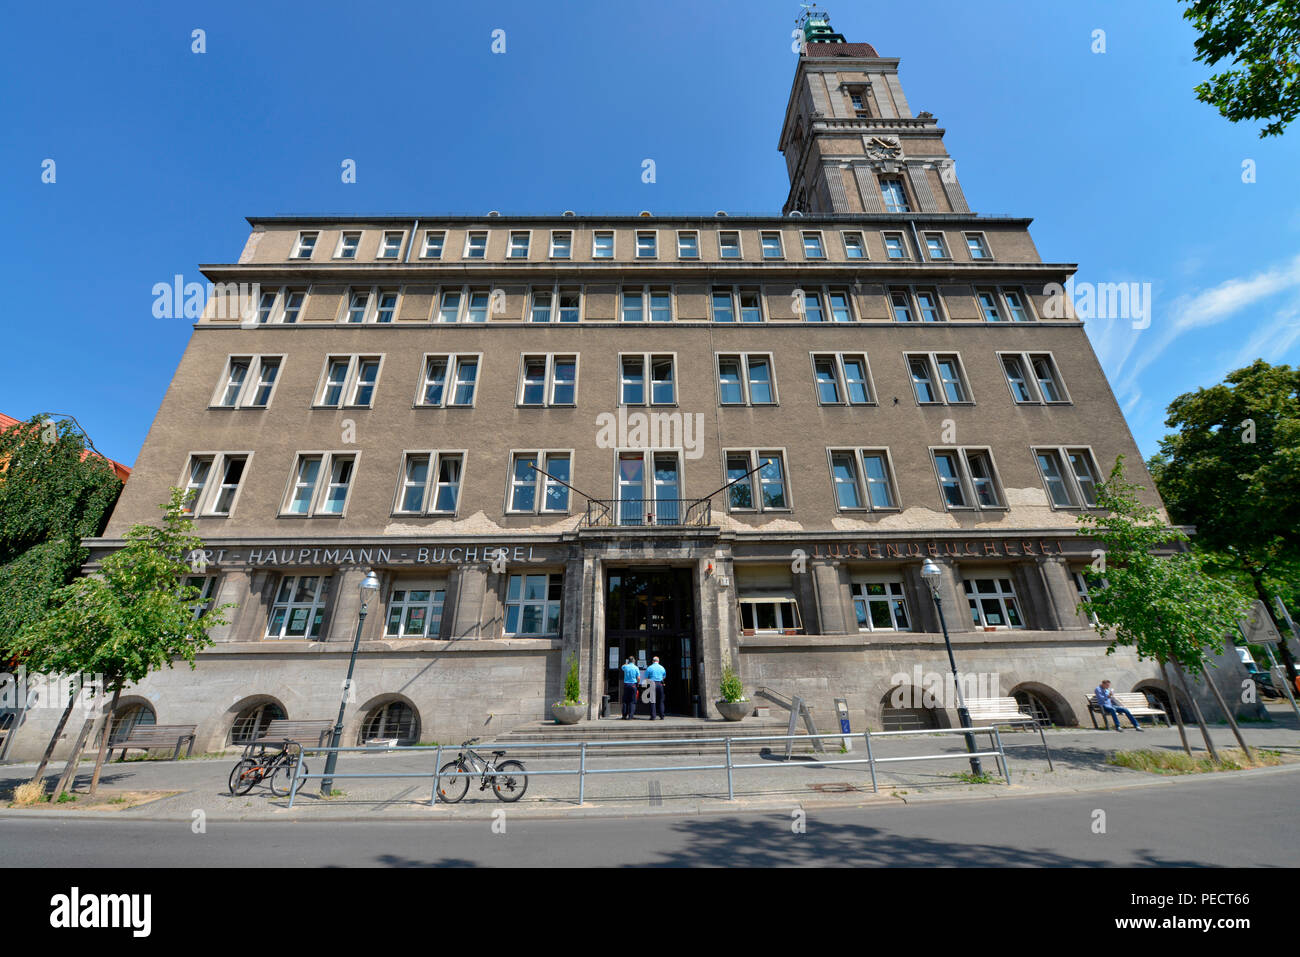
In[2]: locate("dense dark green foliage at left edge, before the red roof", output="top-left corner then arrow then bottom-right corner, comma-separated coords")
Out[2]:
0,415 -> 122,647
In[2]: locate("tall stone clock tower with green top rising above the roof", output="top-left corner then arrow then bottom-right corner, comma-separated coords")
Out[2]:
777,10 -> 971,215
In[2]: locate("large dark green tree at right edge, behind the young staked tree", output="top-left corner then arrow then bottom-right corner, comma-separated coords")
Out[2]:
1148,359 -> 1300,674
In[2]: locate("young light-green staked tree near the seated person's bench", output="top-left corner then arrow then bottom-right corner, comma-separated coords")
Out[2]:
1079,455 -> 1251,759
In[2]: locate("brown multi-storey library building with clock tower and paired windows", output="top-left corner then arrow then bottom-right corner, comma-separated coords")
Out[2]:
7,21 -> 1237,764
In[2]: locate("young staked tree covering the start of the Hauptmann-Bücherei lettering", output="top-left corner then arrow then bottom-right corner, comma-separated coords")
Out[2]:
17,489 -> 230,794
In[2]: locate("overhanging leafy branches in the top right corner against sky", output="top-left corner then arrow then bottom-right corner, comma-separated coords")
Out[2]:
1183,0 -> 1300,139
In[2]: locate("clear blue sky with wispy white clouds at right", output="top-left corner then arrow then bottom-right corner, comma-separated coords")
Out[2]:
0,0 -> 1300,464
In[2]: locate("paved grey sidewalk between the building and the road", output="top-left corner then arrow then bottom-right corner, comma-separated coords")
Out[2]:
0,710 -> 1300,822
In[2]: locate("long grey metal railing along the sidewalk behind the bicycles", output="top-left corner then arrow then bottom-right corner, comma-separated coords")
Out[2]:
289,727 -> 1011,807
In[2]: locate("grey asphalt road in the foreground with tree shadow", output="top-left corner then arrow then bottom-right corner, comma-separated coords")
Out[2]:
0,772 -> 1300,867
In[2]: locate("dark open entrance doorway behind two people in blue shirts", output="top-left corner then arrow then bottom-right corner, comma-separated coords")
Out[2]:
605,567 -> 699,715
